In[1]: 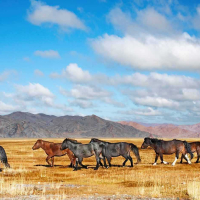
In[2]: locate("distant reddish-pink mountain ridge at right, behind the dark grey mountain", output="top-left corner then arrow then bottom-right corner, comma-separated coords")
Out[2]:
119,121 -> 200,138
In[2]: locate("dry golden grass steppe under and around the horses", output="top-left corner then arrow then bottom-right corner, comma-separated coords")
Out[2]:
0,138 -> 200,199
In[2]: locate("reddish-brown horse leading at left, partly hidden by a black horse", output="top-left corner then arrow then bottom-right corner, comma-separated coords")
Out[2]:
32,139 -> 76,167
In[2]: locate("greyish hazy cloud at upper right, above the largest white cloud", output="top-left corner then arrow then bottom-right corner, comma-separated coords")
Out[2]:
107,7 -> 177,37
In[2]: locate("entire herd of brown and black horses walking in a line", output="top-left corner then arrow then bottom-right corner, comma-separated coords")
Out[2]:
0,137 -> 200,171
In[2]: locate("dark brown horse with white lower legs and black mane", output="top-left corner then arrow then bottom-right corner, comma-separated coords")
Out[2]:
141,138 -> 193,166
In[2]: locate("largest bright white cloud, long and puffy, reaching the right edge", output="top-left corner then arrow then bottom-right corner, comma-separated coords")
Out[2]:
91,33 -> 200,70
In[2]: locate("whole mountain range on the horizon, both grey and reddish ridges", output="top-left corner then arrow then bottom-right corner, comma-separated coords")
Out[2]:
0,112 -> 200,138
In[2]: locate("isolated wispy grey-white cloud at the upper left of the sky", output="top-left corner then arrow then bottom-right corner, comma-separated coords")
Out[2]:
27,0 -> 87,31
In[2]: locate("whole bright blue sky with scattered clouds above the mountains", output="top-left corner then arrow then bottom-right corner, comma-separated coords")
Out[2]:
0,0 -> 200,124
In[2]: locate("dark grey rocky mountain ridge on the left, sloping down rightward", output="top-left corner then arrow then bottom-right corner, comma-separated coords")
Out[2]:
0,112 -> 150,138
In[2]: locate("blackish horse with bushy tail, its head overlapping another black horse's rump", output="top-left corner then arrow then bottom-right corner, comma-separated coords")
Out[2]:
90,138 -> 141,167
